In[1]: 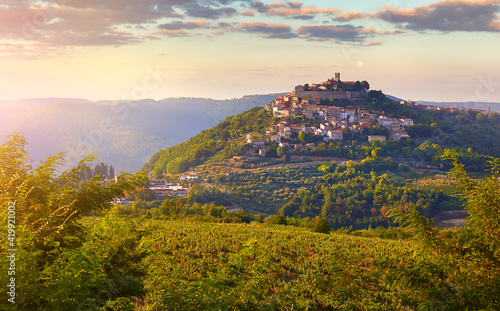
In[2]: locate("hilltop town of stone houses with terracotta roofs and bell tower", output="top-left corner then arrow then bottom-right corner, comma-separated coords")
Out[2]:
266,73 -> 413,150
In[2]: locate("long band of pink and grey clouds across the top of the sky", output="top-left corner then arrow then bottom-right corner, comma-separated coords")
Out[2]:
13,0 -> 490,52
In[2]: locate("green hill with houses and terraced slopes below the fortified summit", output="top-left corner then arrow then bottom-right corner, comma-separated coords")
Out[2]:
143,89 -> 500,229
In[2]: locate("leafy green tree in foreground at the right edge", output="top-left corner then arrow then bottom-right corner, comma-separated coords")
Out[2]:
390,150 -> 500,310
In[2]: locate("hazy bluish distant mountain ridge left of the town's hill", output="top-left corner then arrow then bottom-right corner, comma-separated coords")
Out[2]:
0,94 -> 278,172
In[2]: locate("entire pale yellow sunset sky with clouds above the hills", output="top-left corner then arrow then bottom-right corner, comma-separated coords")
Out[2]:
0,0 -> 500,102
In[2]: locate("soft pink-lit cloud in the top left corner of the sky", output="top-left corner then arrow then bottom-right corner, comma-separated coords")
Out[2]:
0,3 -> 156,46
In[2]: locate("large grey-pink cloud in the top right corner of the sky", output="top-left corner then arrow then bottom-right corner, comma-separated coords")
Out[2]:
335,0 -> 500,32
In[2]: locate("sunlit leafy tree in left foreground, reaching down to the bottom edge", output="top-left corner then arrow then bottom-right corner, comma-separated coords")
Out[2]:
0,132 -> 147,310
